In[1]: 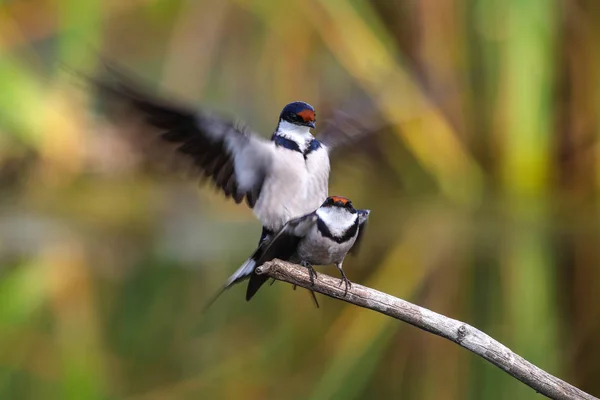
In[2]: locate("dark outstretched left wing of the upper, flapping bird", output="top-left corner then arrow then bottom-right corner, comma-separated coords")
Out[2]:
92,66 -> 272,207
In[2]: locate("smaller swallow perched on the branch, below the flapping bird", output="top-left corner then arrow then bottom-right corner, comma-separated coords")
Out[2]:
209,196 -> 371,305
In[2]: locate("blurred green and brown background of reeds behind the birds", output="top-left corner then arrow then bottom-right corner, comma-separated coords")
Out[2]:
0,0 -> 600,400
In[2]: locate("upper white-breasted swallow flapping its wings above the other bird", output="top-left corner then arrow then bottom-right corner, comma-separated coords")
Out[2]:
89,65 -> 364,243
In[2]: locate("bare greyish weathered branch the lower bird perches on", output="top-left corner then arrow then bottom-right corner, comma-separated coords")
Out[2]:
256,260 -> 598,400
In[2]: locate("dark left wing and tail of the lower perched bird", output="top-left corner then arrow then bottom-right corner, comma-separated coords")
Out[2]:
206,212 -> 317,308
